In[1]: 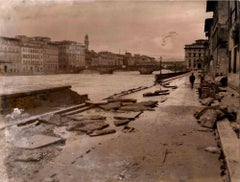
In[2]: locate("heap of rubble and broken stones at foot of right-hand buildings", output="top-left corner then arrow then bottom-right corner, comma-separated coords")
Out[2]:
194,81 -> 239,131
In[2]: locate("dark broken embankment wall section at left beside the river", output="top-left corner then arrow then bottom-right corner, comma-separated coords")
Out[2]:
0,85 -> 88,114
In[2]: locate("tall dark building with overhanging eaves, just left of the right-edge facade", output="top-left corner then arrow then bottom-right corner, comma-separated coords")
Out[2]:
204,0 -> 228,77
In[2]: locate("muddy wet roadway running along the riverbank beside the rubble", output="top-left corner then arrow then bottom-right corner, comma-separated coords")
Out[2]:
29,77 -> 222,182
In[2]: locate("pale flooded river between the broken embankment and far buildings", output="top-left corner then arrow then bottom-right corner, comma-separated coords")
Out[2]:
0,72 -> 168,100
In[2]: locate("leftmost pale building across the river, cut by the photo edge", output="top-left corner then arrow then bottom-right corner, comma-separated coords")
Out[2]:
0,37 -> 21,73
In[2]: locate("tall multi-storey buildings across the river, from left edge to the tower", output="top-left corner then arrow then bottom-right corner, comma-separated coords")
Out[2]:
0,35 -> 88,74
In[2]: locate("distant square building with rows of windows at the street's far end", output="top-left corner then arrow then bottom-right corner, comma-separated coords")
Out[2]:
184,39 -> 208,70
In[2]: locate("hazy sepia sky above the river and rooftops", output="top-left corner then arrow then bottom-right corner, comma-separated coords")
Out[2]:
0,0 -> 211,60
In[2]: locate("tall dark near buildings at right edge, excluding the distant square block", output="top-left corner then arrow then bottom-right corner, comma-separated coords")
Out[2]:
204,0 -> 240,90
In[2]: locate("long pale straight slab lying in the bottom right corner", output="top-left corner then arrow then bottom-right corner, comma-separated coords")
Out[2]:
217,119 -> 240,182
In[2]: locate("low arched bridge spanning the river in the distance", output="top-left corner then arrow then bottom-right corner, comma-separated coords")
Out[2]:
86,65 -> 160,74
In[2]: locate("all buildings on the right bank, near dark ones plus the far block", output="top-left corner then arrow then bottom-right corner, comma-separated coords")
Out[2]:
185,0 -> 240,88
